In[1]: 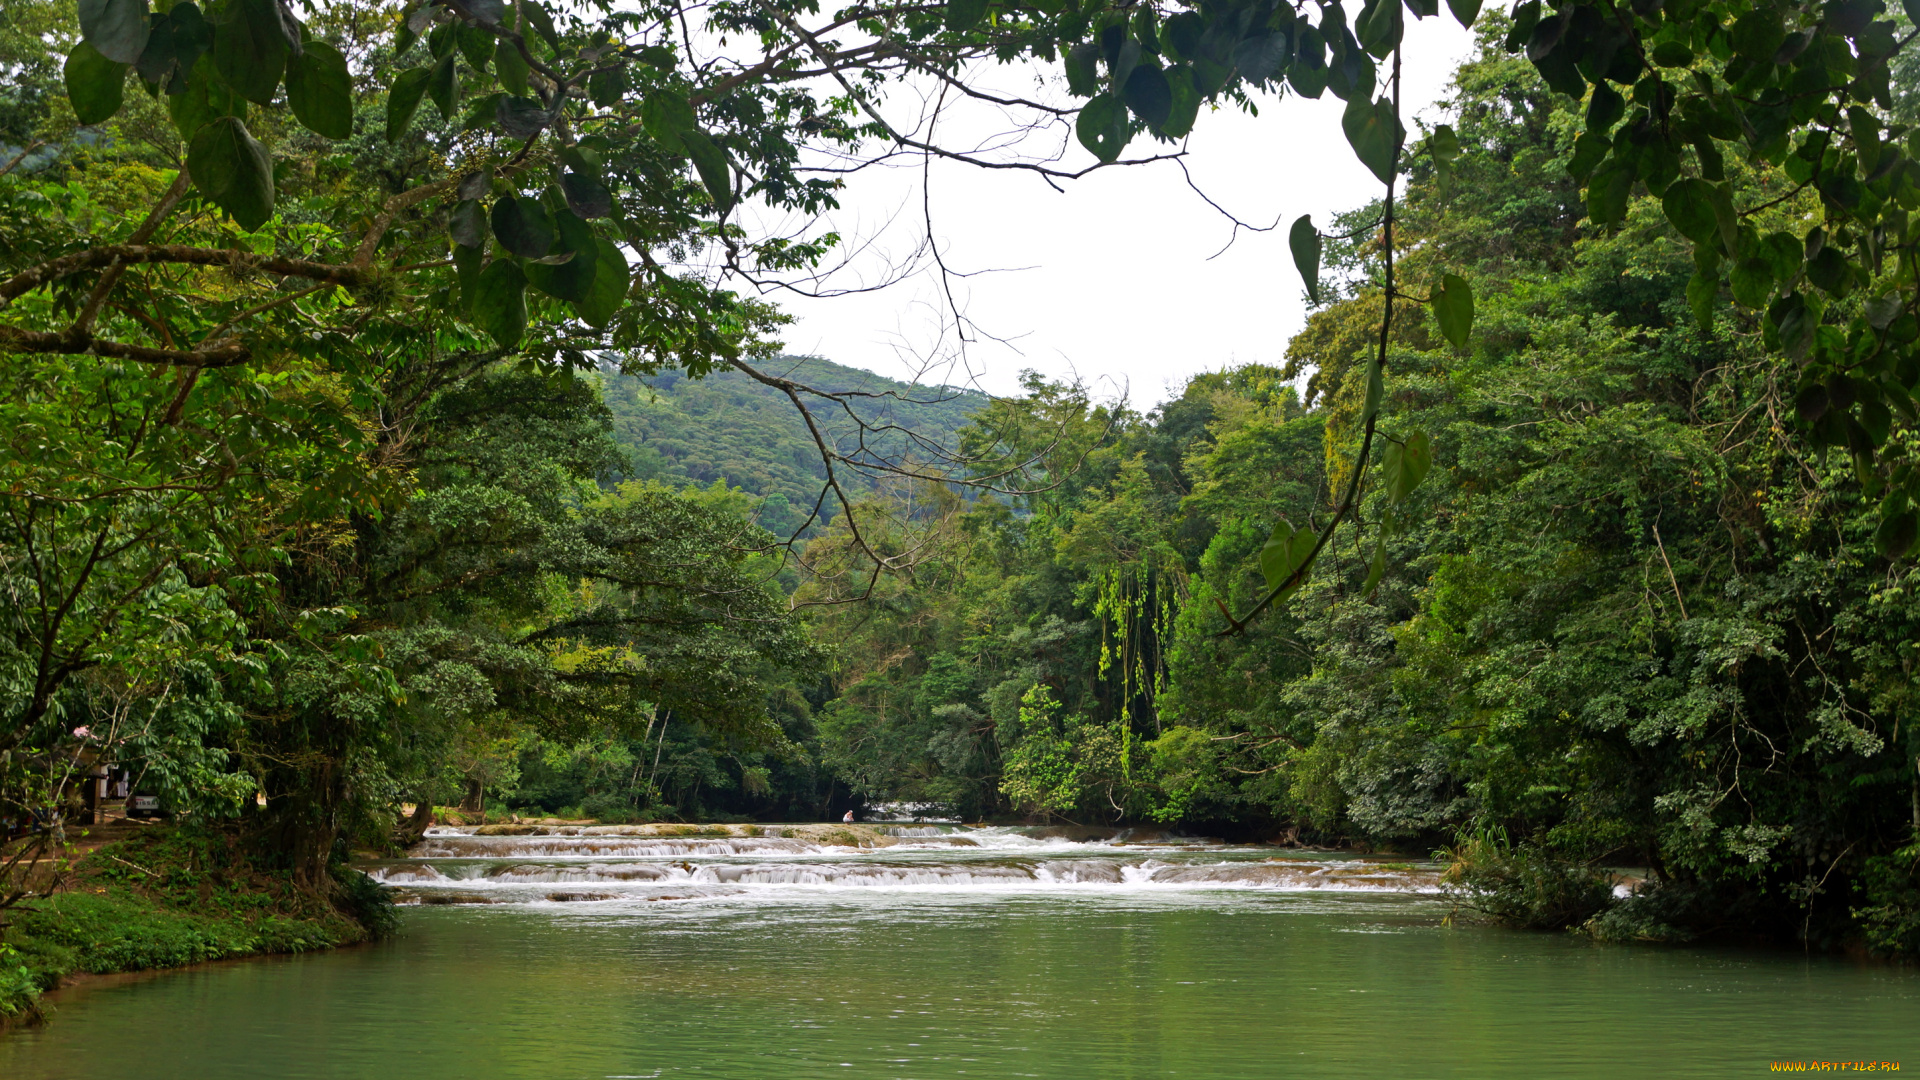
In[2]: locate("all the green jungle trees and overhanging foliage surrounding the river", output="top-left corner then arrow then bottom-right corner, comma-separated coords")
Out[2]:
0,0 -> 1920,1006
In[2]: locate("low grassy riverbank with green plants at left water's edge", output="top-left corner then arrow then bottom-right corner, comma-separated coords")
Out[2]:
0,826 -> 392,1030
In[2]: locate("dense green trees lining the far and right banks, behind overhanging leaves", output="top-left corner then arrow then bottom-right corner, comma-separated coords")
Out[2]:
495,27 -> 1920,951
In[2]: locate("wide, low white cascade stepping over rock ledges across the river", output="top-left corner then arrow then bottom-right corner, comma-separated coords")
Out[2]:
365,824 -> 1438,903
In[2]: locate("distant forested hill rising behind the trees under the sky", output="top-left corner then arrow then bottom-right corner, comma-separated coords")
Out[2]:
603,356 -> 987,532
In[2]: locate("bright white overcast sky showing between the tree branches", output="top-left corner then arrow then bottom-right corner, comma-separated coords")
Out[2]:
741,15 -> 1473,409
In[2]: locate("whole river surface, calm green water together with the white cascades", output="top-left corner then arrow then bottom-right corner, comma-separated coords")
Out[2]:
0,818 -> 1920,1080
